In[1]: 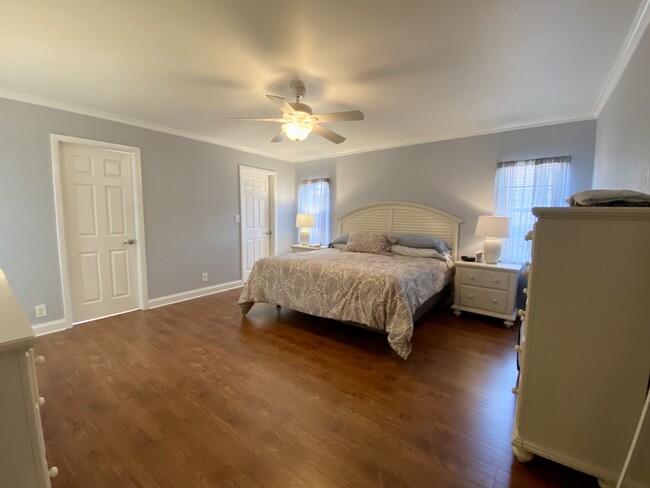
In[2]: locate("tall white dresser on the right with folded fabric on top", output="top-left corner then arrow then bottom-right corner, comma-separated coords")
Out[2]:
512,207 -> 650,487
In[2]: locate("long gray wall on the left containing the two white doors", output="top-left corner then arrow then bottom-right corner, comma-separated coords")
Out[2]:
0,99 -> 296,324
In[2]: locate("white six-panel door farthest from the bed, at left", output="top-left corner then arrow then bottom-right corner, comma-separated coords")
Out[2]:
61,144 -> 139,323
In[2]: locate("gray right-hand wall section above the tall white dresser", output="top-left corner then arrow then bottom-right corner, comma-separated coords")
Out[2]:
593,24 -> 650,193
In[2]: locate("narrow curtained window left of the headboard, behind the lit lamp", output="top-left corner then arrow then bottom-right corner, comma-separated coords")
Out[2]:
297,178 -> 330,246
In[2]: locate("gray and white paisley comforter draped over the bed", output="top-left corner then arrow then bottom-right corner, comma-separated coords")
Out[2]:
239,249 -> 453,359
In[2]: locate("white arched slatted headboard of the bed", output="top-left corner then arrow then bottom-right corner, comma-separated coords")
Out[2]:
338,202 -> 463,259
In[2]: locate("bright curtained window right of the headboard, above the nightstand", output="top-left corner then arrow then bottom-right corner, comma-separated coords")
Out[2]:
494,156 -> 571,263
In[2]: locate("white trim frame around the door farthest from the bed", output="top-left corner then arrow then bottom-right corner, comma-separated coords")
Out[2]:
50,134 -> 149,329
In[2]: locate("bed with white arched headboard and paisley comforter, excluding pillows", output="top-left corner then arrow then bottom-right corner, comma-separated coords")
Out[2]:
239,202 -> 462,359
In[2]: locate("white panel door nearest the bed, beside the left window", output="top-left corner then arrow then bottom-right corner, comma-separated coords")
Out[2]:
240,168 -> 272,281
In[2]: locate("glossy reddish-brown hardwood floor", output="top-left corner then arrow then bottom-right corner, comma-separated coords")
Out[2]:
36,290 -> 597,488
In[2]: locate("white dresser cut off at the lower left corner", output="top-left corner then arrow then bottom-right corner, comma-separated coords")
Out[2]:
0,270 -> 58,488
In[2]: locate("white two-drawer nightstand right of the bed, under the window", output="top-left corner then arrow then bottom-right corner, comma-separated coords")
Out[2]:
451,261 -> 521,327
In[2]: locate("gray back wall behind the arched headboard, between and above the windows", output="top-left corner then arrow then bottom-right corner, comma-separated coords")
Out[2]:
296,120 -> 596,254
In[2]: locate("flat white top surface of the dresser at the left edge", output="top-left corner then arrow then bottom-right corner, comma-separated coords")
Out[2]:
0,269 -> 35,353
